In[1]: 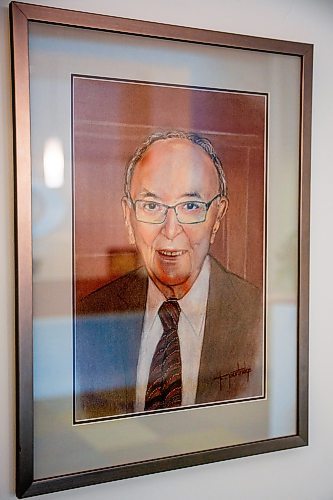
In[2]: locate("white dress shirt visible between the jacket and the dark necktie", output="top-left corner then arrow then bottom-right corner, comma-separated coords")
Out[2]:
135,256 -> 210,412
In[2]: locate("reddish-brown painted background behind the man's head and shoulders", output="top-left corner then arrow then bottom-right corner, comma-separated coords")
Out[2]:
73,77 -> 267,298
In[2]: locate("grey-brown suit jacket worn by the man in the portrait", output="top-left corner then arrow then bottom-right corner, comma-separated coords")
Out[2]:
75,258 -> 264,421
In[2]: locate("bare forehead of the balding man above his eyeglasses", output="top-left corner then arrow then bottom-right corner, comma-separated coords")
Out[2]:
131,139 -> 219,197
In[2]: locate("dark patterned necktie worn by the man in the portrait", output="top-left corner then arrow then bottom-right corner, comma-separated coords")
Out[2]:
145,299 -> 182,410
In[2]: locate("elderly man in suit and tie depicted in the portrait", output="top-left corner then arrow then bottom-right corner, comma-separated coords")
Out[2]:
75,131 -> 264,420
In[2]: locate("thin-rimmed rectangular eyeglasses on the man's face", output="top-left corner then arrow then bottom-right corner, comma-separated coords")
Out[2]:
130,193 -> 221,224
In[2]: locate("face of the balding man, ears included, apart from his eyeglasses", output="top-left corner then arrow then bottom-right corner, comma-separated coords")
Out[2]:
123,139 -> 227,298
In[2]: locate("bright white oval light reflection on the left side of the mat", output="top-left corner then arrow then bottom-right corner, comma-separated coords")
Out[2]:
43,137 -> 65,189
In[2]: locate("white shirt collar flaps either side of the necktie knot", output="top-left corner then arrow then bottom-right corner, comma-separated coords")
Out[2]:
144,255 -> 210,335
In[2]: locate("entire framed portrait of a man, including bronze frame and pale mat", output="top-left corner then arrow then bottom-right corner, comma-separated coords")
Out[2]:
10,2 -> 313,498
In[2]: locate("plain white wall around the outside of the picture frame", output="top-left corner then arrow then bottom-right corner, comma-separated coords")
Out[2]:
0,0 -> 333,500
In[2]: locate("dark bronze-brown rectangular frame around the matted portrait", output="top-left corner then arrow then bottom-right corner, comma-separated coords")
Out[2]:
10,2 -> 313,498
